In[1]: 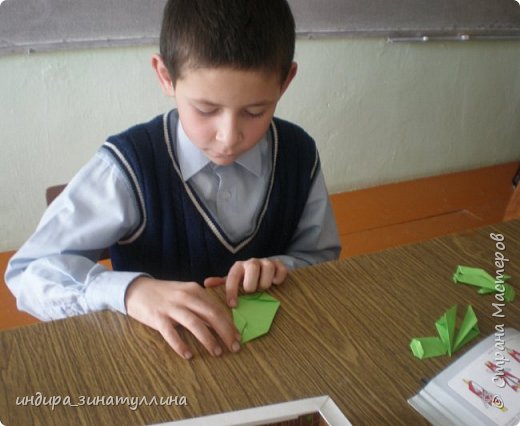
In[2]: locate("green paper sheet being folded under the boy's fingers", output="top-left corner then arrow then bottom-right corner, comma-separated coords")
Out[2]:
232,293 -> 280,343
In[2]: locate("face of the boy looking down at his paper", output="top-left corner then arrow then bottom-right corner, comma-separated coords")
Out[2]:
152,57 -> 296,166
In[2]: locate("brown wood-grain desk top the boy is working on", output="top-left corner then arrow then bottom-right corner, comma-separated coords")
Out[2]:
0,221 -> 520,425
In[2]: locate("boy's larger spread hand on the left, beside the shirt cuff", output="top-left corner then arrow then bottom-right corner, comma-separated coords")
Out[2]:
125,277 -> 240,359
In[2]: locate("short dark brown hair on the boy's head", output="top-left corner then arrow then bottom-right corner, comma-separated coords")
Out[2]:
160,0 -> 295,84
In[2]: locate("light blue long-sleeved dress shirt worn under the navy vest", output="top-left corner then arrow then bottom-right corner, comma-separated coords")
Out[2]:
5,115 -> 341,320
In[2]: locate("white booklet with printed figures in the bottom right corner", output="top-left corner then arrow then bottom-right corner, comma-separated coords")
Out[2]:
408,328 -> 520,426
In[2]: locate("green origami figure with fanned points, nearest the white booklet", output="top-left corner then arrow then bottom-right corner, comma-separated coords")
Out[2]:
410,305 -> 480,359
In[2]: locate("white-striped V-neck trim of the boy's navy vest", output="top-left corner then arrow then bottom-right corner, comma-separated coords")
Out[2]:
163,110 -> 278,254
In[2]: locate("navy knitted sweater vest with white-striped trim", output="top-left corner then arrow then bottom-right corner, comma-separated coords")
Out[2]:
103,110 -> 319,283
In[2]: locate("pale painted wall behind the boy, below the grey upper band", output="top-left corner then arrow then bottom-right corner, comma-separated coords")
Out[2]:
0,38 -> 520,250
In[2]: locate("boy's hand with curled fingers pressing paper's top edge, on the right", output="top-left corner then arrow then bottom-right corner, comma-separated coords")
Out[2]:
204,258 -> 287,308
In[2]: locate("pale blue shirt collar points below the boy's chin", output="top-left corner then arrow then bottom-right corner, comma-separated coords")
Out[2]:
175,119 -> 269,182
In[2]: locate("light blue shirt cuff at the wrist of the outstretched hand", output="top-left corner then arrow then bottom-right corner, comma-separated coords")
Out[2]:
85,271 -> 147,315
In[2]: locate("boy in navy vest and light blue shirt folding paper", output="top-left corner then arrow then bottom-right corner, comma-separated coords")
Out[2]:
6,0 -> 346,359
